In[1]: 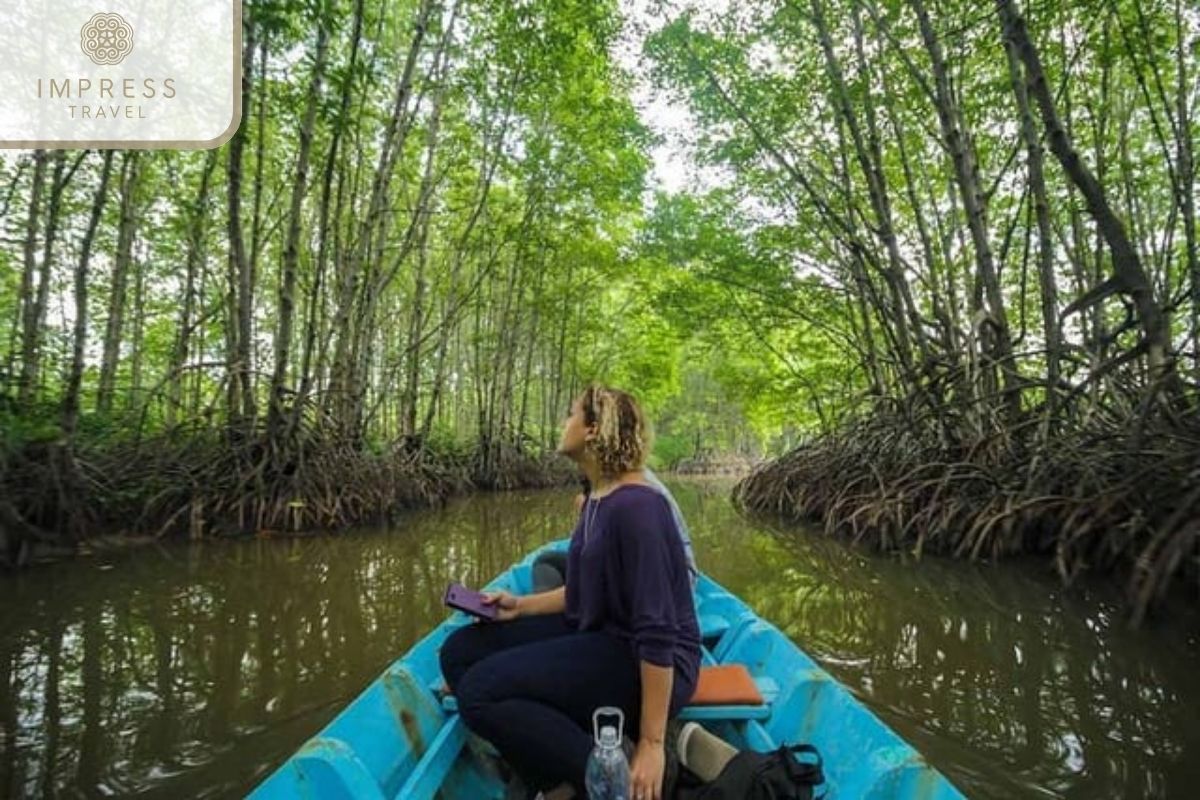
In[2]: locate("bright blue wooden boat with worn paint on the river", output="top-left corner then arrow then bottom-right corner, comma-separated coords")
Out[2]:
251,540 -> 962,800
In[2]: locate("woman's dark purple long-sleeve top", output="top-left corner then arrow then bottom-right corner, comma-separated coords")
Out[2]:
566,483 -> 700,714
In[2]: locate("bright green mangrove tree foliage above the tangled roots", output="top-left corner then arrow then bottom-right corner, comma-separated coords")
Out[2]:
0,0 -> 1200,491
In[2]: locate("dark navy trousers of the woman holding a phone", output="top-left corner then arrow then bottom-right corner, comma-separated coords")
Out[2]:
440,614 -> 642,798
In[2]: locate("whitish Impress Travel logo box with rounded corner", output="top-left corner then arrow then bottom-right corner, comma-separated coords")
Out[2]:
0,0 -> 245,149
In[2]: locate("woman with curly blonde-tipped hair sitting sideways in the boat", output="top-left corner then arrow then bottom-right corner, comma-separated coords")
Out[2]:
440,385 -> 700,800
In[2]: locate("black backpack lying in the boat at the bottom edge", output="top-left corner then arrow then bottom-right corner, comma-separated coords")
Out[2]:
676,745 -> 824,800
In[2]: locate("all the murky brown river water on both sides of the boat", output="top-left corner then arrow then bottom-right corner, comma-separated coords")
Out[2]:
0,480 -> 1200,798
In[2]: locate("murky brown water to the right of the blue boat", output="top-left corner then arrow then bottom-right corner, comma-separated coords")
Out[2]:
676,482 -> 1200,798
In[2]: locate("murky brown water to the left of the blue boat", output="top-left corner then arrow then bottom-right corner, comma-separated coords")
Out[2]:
0,493 -> 570,798
